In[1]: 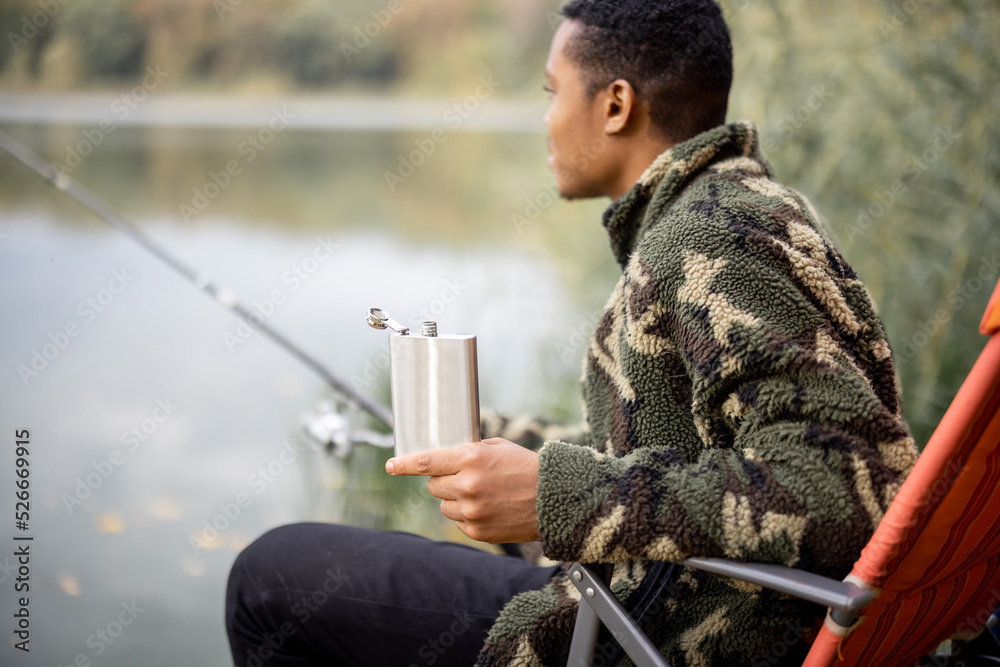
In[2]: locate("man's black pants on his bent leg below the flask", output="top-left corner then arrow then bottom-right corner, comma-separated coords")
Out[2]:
226,523 -> 559,667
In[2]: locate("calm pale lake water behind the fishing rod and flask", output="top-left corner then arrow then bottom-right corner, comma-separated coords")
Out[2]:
0,115 -> 616,666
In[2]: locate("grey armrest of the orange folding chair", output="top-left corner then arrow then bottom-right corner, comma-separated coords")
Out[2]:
682,558 -> 875,626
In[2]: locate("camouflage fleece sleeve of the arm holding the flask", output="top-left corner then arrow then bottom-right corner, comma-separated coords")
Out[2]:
538,196 -> 916,576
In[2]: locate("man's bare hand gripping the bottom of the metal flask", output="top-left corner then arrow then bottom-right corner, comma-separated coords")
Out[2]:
385,438 -> 538,544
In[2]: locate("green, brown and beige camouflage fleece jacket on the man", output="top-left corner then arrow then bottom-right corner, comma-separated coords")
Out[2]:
478,123 -> 917,667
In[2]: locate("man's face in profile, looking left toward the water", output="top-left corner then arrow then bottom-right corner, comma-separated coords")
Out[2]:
545,20 -> 612,199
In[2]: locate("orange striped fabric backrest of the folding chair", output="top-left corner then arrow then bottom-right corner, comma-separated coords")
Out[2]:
804,284 -> 1000,667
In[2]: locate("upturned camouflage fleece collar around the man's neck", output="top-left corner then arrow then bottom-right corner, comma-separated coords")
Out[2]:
604,121 -> 771,269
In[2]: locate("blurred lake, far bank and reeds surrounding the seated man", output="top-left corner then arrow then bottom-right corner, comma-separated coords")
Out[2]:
0,0 -> 1000,666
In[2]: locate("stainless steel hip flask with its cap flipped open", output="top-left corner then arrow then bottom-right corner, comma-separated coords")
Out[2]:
368,308 -> 480,455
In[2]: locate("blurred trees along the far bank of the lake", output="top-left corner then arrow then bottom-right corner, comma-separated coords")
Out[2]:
0,0 -> 551,89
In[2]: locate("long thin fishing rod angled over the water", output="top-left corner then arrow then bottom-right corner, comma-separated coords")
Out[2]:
0,130 -> 392,434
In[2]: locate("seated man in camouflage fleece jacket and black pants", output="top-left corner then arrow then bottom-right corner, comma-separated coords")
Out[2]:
229,0 -> 916,667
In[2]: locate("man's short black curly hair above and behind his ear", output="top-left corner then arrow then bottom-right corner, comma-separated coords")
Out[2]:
562,0 -> 733,142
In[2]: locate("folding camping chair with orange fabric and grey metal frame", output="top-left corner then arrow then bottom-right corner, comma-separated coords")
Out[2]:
568,283 -> 1000,667
